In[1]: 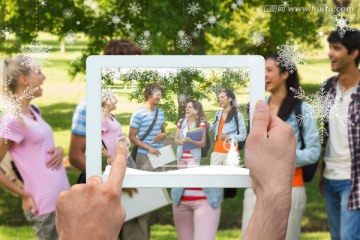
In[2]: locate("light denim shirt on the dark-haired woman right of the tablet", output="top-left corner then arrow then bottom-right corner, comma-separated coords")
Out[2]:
266,98 -> 321,167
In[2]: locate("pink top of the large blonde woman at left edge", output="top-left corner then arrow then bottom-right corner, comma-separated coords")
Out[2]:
0,106 -> 70,215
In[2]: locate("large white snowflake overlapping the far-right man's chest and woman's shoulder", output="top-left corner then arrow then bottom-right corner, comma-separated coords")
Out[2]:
290,87 -> 353,143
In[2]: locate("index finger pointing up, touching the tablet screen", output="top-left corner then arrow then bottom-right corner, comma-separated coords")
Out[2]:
106,142 -> 127,195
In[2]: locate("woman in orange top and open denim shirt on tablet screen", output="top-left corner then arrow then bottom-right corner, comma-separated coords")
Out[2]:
210,90 -> 247,165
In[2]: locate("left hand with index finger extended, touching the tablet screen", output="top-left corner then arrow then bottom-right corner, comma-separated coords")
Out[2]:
56,142 -> 127,239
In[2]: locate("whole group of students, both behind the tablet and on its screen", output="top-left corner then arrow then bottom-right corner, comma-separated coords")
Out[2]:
0,27 -> 360,240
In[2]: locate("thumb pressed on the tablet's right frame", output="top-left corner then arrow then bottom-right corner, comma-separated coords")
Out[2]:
250,100 -> 270,136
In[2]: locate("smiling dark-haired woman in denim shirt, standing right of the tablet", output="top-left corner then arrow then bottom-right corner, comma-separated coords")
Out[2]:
242,54 -> 321,240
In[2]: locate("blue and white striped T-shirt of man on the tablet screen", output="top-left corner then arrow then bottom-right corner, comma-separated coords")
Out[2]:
130,107 -> 165,155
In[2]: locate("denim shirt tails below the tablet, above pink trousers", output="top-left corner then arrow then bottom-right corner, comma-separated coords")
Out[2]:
171,188 -> 224,208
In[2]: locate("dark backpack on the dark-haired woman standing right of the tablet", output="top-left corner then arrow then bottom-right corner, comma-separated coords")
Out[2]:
295,100 -> 319,182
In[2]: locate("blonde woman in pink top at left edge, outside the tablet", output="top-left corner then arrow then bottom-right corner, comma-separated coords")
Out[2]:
0,56 -> 70,240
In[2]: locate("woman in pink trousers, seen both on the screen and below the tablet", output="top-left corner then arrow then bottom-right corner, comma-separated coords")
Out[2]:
171,100 -> 223,240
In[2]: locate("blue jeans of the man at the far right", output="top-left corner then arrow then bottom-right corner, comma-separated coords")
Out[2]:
324,179 -> 360,240
